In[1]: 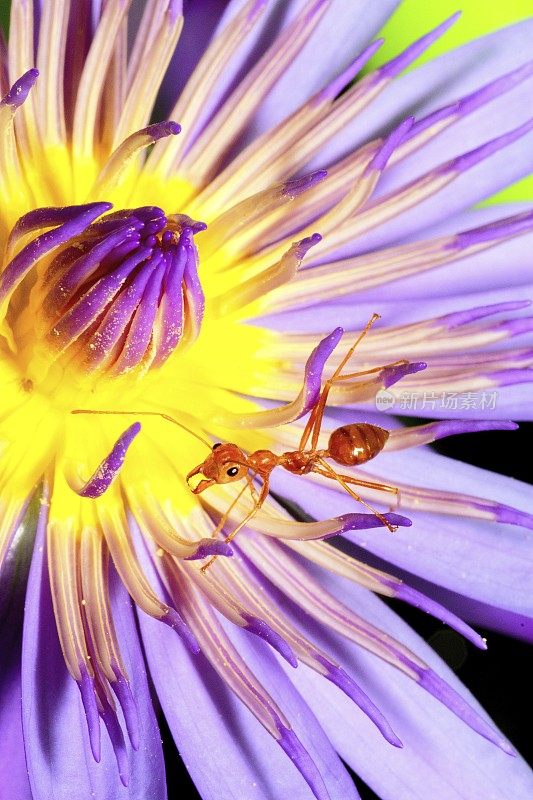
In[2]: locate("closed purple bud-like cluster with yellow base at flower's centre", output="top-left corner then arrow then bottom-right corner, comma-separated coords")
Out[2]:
6,206 -> 206,392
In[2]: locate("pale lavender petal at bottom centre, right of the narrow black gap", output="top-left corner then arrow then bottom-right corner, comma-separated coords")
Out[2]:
133,520 -> 358,800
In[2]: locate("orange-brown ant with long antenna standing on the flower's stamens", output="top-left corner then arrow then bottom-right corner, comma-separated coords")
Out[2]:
72,314 -> 407,573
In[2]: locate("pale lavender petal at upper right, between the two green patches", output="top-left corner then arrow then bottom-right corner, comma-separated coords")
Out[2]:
310,20 -> 533,252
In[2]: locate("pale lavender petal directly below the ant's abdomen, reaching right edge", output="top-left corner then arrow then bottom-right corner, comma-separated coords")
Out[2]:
272,447 -> 533,626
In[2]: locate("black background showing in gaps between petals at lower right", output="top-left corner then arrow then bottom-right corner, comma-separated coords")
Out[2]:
161,420 -> 533,800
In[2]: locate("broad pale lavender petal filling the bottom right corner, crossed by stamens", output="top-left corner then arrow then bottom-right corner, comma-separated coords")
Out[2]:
274,568 -> 533,800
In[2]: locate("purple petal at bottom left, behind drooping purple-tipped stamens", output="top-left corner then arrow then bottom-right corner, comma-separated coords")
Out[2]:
22,496 -> 166,800
